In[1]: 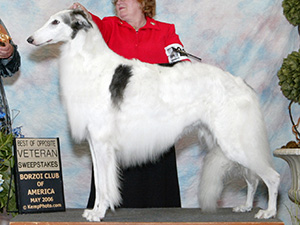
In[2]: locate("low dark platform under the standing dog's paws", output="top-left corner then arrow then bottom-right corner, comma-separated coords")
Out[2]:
10,208 -> 284,225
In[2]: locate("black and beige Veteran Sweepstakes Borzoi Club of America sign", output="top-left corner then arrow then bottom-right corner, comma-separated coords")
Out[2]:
14,138 -> 65,213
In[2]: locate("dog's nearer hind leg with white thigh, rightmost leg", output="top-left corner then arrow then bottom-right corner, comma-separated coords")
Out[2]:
214,100 -> 280,219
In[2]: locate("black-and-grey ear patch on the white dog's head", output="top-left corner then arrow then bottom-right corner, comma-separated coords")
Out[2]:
67,10 -> 93,39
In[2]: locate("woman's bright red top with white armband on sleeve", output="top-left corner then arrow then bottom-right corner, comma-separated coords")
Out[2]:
91,14 -> 187,63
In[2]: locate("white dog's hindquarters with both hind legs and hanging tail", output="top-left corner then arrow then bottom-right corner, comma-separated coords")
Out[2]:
199,89 -> 280,218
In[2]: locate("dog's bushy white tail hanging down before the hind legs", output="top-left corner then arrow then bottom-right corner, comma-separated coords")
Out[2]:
198,145 -> 233,212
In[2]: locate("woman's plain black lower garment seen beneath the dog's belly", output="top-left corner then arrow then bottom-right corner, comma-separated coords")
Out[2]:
87,146 -> 181,208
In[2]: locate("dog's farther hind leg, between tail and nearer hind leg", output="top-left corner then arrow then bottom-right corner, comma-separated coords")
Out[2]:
233,168 -> 259,212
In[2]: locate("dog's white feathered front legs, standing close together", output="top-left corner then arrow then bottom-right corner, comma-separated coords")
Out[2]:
83,139 -> 120,221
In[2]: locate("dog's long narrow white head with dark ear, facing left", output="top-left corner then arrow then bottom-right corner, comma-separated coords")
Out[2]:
27,10 -> 93,46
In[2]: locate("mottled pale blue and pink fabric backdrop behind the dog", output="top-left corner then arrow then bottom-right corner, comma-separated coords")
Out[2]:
0,0 -> 299,224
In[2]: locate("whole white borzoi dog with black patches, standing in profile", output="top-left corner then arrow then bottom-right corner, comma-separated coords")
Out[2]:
28,10 -> 280,221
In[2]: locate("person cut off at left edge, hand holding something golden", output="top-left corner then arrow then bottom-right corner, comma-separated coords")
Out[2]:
0,19 -> 21,133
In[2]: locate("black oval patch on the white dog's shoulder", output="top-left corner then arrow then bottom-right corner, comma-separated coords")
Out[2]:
109,65 -> 133,108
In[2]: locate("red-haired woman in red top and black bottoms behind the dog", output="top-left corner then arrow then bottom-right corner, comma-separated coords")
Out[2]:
71,0 -> 188,208
